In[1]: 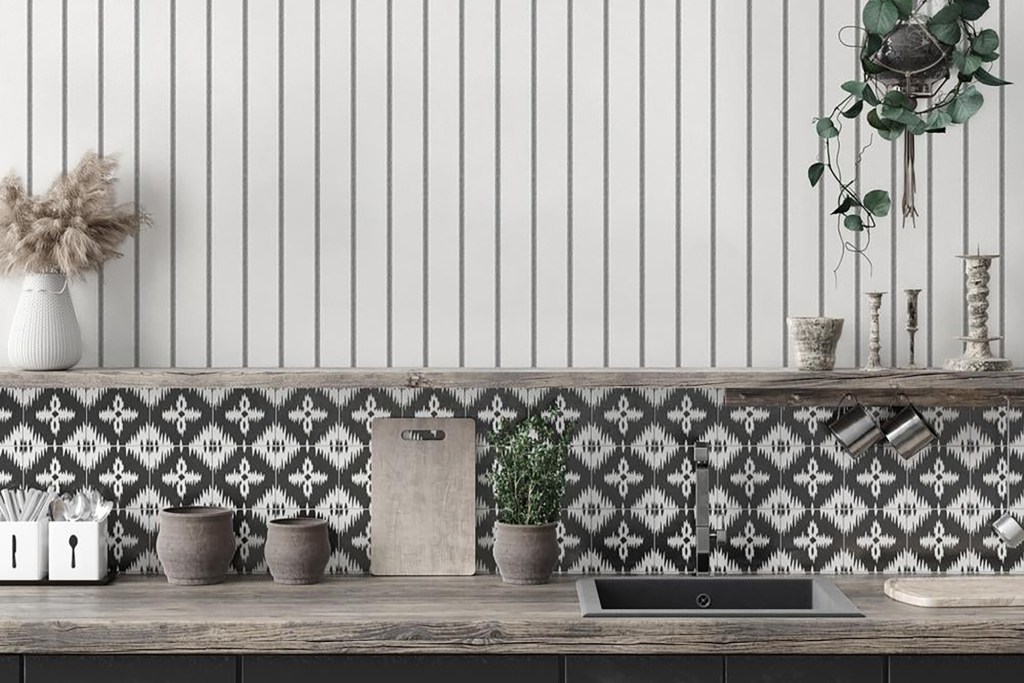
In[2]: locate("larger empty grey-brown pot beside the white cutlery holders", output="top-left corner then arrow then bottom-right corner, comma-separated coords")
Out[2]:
157,507 -> 234,586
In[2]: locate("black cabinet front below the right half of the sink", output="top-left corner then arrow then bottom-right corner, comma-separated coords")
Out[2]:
725,654 -> 895,683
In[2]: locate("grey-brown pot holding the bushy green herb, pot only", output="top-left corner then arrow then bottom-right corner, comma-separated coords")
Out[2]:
495,522 -> 558,586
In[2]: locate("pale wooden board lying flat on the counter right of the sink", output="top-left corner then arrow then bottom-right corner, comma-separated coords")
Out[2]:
885,577 -> 1024,607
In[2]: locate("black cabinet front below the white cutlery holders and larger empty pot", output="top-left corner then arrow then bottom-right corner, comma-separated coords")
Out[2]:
24,654 -> 236,683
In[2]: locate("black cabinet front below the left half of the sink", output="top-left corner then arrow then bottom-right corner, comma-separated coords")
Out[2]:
565,654 -> 722,683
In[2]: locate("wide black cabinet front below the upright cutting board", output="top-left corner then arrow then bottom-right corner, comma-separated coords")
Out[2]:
242,654 -> 559,683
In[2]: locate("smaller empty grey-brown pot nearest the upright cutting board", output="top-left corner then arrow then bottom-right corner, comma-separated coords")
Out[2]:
266,517 -> 331,586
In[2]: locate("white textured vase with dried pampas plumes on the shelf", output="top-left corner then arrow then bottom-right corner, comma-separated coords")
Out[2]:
0,152 -> 147,370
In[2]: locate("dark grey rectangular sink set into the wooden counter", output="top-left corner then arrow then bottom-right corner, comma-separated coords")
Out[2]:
577,577 -> 863,618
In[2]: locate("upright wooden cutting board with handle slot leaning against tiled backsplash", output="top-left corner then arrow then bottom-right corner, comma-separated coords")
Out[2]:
370,419 -> 476,577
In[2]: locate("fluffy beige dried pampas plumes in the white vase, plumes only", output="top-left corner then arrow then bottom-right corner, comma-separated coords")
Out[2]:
0,152 -> 150,278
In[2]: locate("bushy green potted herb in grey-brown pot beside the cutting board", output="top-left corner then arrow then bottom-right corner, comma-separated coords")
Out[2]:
488,413 -> 569,585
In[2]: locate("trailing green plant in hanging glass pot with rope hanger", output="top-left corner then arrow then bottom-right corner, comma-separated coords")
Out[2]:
807,0 -> 1010,262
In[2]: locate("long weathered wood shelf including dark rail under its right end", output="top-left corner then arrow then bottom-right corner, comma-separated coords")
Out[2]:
0,369 -> 1024,405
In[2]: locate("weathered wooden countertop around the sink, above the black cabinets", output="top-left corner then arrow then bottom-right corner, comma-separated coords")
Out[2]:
0,577 -> 1024,654
